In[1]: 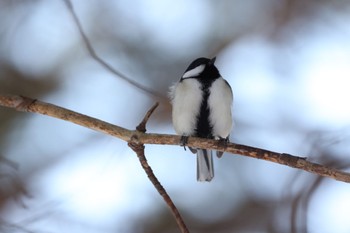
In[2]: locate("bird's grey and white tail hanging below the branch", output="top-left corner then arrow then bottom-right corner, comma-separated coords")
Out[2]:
197,149 -> 214,181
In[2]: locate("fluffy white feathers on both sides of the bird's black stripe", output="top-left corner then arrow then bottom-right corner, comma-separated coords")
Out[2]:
171,77 -> 233,138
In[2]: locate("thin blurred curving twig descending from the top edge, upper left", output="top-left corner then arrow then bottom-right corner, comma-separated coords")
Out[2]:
62,0 -> 164,99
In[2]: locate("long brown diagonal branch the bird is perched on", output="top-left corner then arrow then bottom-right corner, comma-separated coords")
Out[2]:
0,94 -> 350,183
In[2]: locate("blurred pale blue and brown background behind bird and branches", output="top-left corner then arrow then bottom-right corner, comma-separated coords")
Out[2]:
0,0 -> 350,233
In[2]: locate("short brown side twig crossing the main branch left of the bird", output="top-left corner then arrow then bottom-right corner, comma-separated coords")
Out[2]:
128,103 -> 189,233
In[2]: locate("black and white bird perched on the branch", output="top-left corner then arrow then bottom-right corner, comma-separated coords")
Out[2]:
170,57 -> 233,181
